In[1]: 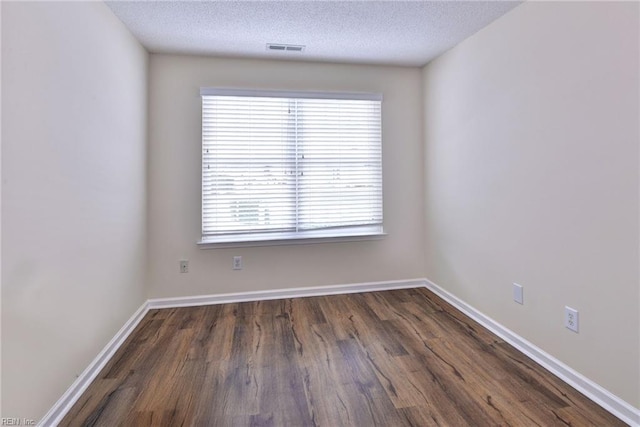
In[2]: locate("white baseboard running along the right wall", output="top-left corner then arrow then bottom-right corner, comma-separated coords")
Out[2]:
425,279 -> 640,426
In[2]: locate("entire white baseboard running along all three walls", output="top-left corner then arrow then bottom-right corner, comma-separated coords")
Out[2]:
38,279 -> 640,426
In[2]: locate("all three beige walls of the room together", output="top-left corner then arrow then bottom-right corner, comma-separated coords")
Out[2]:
0,2 -> 640,418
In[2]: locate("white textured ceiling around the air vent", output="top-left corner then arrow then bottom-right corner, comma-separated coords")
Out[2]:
106,1 -> 520,66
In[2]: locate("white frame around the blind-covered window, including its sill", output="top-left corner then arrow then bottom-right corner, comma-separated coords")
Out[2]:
197,87 -> 386,249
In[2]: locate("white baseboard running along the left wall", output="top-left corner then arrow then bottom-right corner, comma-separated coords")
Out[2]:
38,302 -> 149,427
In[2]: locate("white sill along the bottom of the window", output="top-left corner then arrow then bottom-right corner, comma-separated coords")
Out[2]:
198,227 -> 387,249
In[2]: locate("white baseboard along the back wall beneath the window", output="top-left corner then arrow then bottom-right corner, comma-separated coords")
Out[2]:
147,279 -> 425,309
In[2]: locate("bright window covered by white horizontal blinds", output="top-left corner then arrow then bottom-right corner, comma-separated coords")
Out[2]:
201,88 -> 382,243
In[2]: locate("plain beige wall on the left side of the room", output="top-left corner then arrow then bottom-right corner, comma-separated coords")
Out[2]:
2,2 -> 147,419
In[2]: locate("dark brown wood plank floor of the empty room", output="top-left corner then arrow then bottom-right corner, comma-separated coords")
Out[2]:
61,289 -> 625,427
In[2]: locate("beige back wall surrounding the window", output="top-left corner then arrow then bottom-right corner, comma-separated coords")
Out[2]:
149,54 -> 424,298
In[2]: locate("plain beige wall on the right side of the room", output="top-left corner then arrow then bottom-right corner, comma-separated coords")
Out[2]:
424,2 -> 640,407
